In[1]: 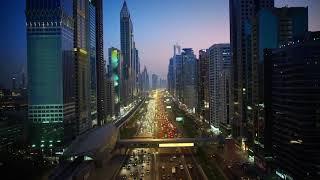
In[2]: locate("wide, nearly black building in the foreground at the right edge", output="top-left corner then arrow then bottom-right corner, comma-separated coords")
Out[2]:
264,32 -> 320,179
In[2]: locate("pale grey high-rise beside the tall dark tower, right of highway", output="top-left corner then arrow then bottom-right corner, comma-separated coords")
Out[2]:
208,44 -> 233,131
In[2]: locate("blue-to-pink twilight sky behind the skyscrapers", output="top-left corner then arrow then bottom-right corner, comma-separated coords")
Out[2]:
0,0 -> 320,88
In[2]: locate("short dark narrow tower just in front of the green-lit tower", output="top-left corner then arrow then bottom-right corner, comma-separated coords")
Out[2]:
106,75 -> 115,123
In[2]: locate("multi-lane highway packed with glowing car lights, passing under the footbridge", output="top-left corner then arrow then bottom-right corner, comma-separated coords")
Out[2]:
116,91 -> 204,180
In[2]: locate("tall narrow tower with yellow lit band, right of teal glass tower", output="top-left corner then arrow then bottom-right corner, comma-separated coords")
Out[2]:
73,0 -> 92,136
